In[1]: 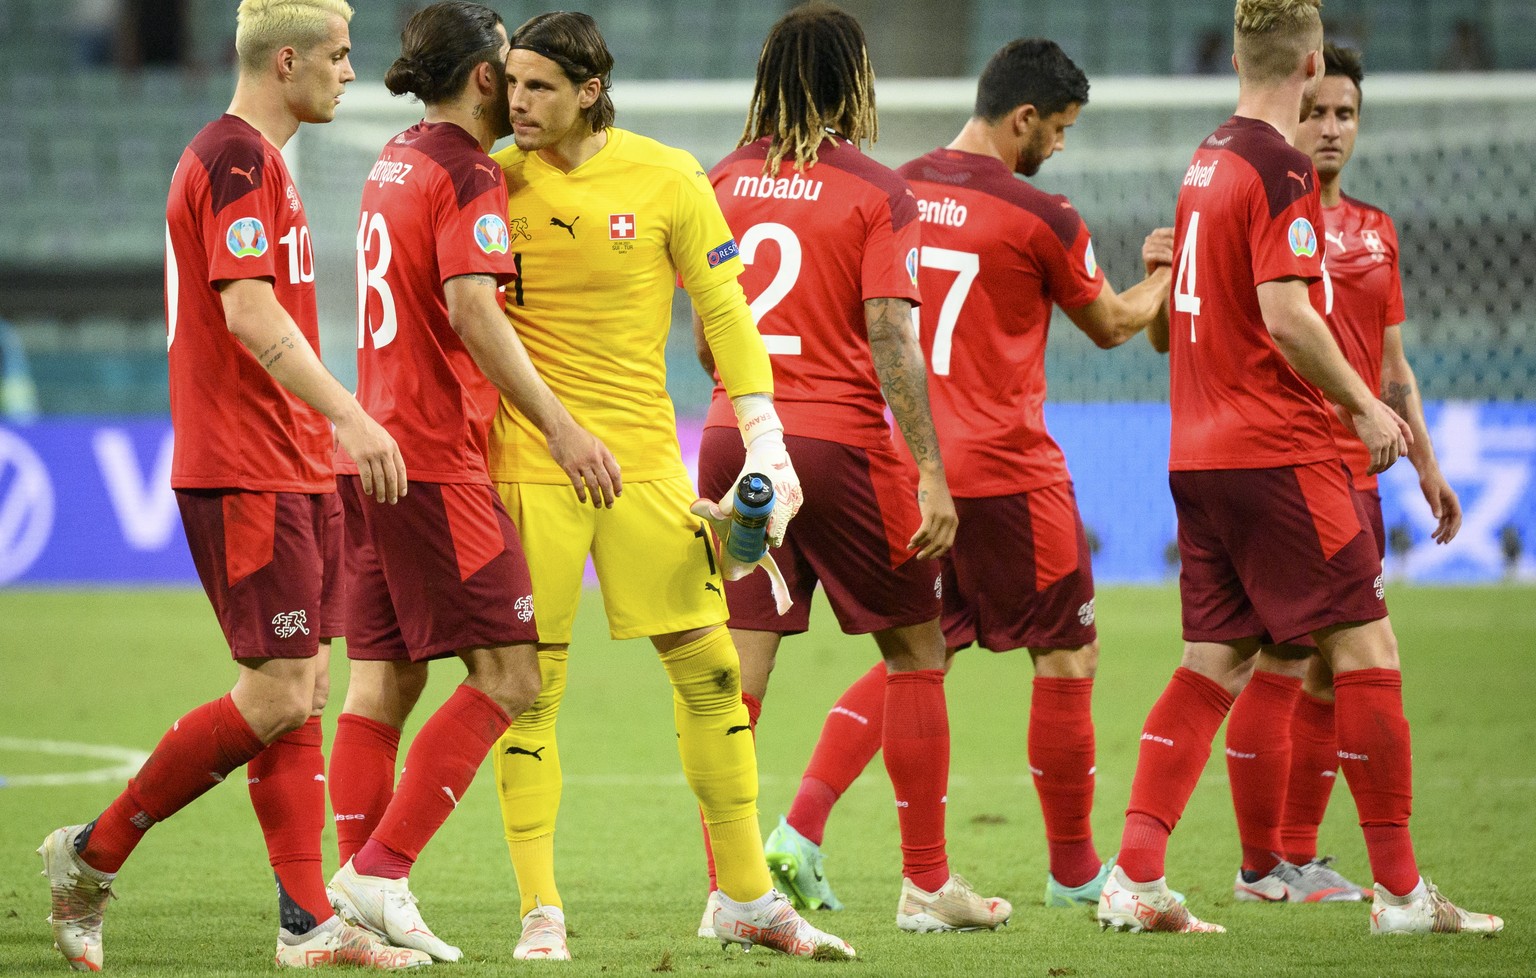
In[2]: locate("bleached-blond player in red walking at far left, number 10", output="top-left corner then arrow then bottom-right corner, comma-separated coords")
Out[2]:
38,0 -> 427,970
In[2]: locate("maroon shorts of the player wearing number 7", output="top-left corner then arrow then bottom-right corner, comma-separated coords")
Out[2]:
942,482 -> 1098,653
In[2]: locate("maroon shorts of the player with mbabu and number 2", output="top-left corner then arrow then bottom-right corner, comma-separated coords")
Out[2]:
699,427 -> 940,636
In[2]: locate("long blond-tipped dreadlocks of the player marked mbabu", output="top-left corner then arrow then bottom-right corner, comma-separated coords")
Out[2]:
737,3 -> 880,173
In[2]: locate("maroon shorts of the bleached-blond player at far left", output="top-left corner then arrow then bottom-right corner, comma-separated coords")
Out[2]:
177,490 -> 333,659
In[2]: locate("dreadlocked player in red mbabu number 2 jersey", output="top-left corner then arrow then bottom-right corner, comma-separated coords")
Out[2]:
696,6 -> 1012,930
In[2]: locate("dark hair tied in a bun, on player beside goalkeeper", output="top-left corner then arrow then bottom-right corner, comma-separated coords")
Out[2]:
384,0 -> 504,104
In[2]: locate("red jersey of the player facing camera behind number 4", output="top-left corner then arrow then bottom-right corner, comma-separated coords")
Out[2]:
1322,195 -> 1405,490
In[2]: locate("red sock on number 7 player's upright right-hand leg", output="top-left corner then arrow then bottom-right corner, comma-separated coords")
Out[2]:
1029,676 -> 1101,886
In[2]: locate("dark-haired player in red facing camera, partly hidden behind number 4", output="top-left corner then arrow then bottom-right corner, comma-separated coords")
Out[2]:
1198,45 -> 1461,903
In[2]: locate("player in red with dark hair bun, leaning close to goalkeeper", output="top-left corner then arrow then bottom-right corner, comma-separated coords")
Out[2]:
330,2 -> 621,961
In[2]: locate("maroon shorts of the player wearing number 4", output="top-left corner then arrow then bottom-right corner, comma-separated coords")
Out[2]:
1167,461 -> 1387,642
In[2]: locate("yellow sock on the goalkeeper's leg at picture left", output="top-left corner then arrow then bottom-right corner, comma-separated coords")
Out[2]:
492,648 -> 568,914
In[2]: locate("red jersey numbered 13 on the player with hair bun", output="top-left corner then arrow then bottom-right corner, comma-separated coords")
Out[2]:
341,123 -> 518,485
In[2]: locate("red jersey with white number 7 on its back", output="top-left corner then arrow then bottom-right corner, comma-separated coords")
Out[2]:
897,149 -> 1104,497
